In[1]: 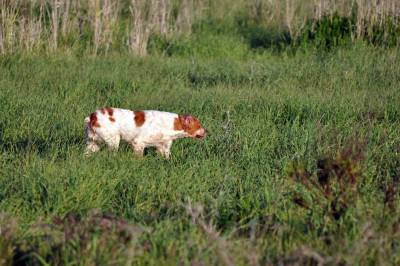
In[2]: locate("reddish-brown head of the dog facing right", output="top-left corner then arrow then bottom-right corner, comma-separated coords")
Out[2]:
174,114 -> 207,139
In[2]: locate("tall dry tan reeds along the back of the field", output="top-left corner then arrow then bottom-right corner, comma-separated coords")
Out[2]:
0,0 -> 400,55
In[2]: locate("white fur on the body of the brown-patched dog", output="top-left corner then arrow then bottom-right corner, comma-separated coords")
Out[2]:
85,108 -> 204,159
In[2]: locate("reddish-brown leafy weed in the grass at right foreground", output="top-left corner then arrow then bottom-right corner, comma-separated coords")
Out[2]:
288,137 -> 365,224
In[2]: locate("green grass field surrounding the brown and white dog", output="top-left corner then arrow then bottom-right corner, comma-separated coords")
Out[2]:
0,44 -> 400,265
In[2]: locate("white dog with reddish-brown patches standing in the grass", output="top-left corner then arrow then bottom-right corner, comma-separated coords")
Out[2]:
85,108 -> 206,159
